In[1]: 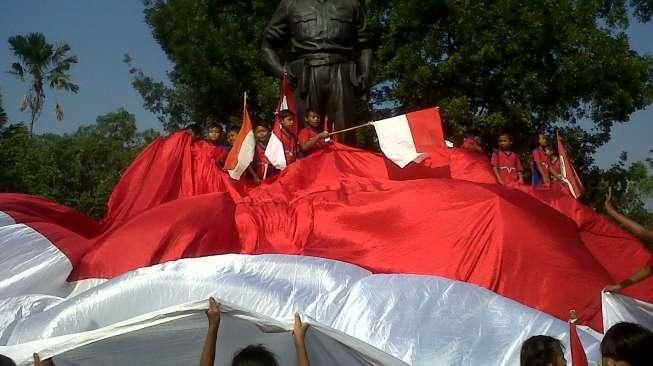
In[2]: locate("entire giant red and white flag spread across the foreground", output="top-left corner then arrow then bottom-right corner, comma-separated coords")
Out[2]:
0,107 -> 653,366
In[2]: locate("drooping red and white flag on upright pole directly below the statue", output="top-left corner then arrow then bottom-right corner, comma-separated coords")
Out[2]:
265,74 -> 298,170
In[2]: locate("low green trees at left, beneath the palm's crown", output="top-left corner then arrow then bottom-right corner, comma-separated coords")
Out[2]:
0,109 -> 158,218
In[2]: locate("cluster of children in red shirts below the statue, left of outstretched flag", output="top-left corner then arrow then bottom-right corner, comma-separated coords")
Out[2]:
187,109 -> 330,184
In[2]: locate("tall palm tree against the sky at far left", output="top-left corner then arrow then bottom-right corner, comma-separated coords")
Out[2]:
9,33 -> 79,134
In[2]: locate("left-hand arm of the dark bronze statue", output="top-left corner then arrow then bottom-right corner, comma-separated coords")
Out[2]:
261,0 -> 289,77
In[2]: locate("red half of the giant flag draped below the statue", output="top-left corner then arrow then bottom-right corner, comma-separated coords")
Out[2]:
0,139 -> 653,330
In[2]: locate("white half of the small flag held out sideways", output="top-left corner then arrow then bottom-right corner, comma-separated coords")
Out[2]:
372,114 -> 425,168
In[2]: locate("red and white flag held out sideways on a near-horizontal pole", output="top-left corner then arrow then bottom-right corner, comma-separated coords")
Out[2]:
372,107 -> 445,168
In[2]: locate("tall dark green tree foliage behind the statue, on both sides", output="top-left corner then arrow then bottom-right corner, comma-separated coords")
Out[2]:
129,0 -> 653,217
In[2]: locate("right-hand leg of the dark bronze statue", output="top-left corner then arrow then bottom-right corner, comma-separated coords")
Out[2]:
326,62 -> 358,146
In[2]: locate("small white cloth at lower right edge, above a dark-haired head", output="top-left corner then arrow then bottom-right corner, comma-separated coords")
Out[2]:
601,292 -> 653,331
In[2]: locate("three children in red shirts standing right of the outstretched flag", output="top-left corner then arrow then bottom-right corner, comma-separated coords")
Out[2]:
462,133 -> 565,189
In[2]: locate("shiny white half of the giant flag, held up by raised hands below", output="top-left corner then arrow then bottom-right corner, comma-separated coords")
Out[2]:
0,214 -> 600,366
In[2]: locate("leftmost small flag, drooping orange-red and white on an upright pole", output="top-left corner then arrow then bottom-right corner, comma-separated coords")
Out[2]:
224,98 -> 256,180
